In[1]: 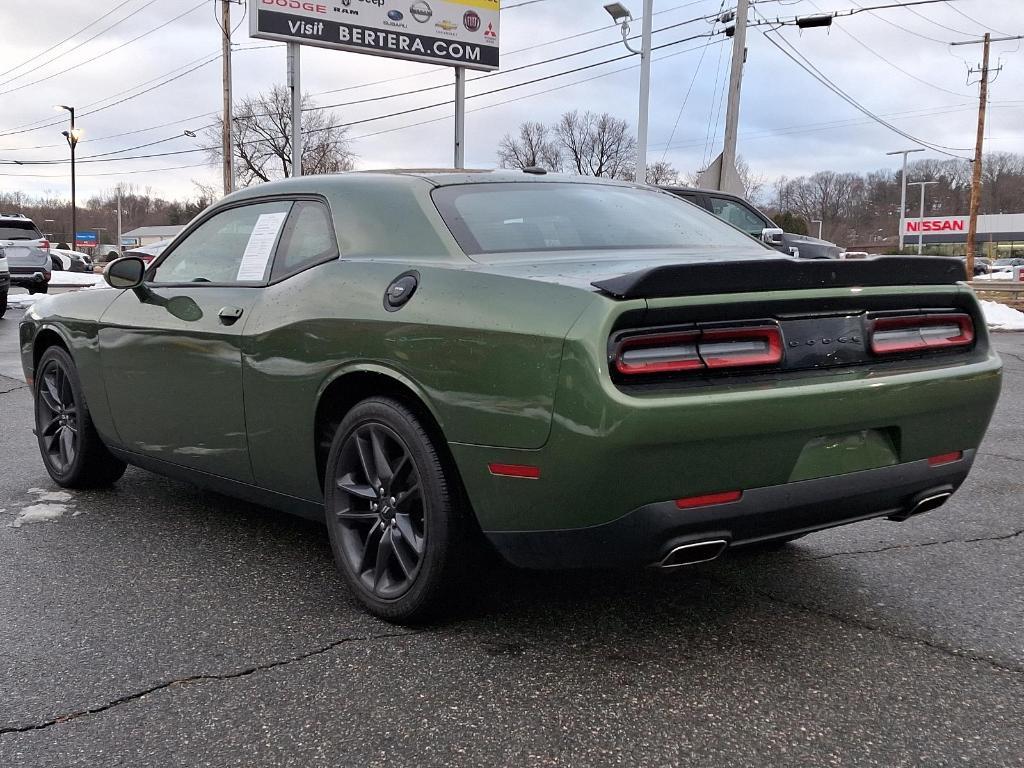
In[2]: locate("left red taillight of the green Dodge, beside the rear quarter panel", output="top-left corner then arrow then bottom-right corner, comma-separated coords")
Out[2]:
613,326 -> 782,376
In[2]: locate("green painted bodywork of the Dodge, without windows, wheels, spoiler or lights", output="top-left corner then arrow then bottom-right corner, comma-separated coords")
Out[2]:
22,173 -> 1000,564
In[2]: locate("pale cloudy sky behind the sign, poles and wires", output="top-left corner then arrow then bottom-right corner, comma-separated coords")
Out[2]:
0,0 -> 1024,198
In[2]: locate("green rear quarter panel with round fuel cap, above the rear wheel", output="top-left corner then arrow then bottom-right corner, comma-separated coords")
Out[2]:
243,260 -> 595,499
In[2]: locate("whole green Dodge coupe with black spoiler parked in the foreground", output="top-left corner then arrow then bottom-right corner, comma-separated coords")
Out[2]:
20,169 -> 1000,621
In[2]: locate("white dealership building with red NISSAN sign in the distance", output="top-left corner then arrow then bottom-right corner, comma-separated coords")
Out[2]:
903,213 -> 1024,259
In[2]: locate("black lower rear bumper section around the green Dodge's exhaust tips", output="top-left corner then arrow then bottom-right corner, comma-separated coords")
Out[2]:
484,451 -> 975,568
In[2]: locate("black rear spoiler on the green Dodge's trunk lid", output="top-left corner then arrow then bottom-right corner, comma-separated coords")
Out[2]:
591,256 -> 967,299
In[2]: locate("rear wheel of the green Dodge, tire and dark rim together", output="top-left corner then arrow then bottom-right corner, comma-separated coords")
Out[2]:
324,397 -> 472,624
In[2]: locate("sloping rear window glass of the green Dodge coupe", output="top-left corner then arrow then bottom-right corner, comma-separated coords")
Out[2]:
433,182 -> 763,256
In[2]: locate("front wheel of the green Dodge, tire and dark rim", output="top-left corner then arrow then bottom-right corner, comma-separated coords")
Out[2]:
33,346 -> 126,488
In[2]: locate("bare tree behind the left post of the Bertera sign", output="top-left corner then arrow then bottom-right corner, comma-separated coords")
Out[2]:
204,85 -> 355,186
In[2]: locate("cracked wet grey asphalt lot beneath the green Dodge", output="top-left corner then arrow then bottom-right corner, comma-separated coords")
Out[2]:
0,296 -> 1024,768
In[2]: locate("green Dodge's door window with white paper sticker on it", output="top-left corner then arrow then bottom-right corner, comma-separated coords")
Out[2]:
152,201 -> 292,284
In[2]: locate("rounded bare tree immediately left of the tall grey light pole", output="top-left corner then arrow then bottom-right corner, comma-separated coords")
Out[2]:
554,110 -> 637,178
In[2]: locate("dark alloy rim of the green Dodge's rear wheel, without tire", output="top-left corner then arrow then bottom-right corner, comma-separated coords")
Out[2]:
333,422 -> 427,599
